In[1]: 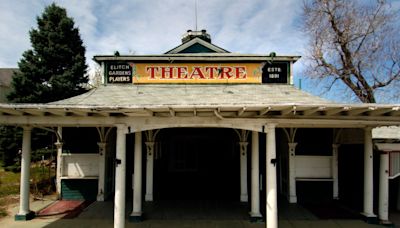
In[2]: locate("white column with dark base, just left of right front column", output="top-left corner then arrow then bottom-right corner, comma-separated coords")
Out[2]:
250,131 -> 262,218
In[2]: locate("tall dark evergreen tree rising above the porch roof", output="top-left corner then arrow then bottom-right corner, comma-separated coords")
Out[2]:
8,3 -> 88,103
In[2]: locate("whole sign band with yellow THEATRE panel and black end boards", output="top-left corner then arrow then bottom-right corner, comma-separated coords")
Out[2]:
105,62 -> 289,84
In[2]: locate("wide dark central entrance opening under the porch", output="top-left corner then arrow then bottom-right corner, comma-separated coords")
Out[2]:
154,128 -> 240,200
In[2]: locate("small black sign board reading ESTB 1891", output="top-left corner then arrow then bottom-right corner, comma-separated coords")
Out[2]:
262,62 -> 289,83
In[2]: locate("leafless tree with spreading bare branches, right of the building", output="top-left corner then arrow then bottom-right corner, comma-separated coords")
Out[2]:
302,0 -> 400,103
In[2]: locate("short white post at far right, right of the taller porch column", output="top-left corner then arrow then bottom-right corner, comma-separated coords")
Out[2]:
378,152 -> 389,222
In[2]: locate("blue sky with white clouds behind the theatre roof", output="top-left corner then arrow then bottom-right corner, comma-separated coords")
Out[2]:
0,0 -> 400,101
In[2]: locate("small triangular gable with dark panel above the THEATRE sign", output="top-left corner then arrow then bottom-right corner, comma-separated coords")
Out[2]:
165,37 -> 229,54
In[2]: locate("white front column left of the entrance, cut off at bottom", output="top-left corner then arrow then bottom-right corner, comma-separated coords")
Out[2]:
114,124 -> 127,228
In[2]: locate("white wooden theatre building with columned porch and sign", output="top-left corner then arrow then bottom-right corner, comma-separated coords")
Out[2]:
0,30 -> 400,228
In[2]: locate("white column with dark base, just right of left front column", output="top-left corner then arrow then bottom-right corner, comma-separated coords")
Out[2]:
130,131 -> 142,222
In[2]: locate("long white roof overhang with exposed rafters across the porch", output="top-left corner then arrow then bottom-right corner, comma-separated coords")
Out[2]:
0,103 -> 400,128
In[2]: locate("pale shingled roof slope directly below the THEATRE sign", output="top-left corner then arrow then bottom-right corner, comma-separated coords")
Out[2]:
50,84 -> 332,107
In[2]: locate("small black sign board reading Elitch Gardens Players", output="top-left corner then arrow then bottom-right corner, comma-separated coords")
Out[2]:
106,62 -> 132,83
